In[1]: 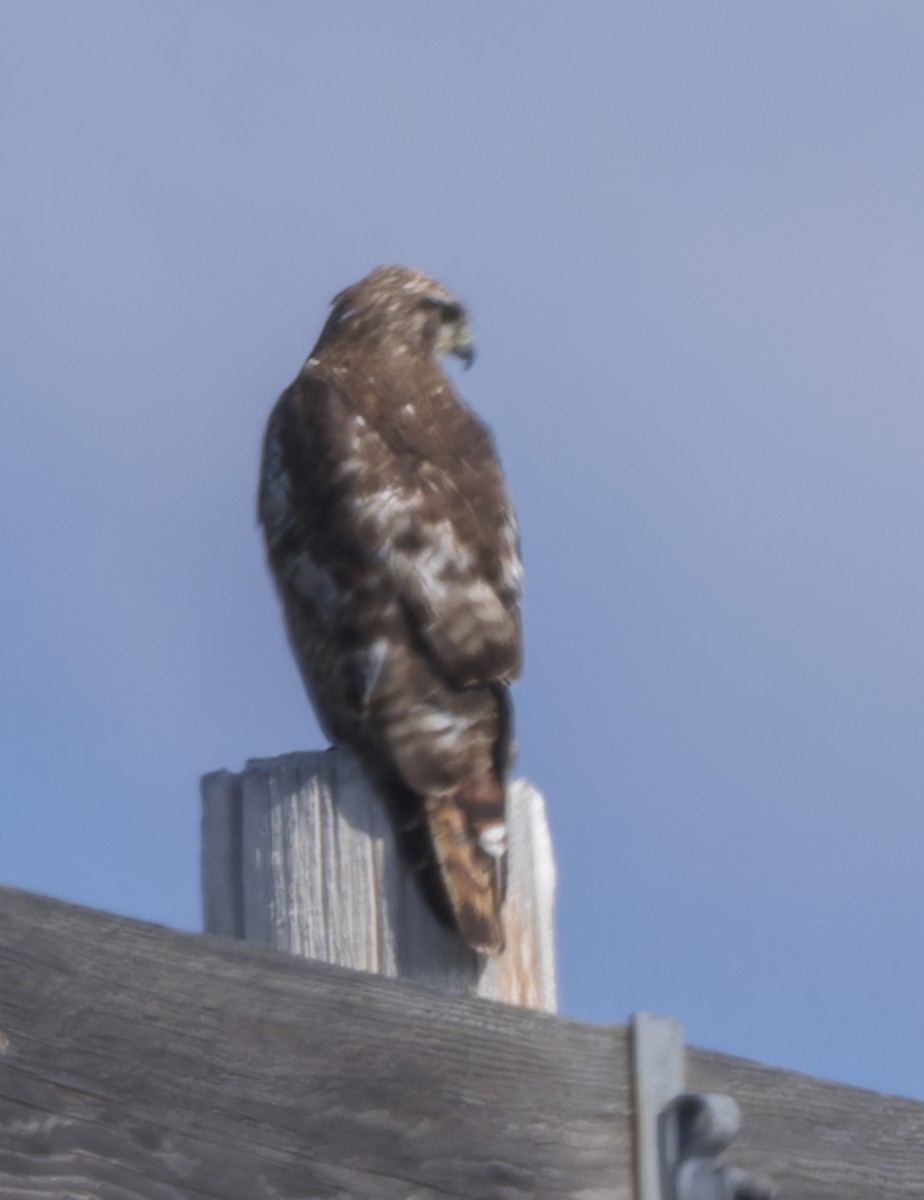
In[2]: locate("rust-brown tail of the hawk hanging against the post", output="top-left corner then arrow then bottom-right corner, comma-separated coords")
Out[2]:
425,773 -> 506,954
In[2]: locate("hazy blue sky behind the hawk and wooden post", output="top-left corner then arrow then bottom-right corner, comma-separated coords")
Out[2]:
0,0 -> 924,1098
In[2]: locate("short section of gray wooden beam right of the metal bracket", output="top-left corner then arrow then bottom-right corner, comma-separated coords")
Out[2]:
686,1049 -> 924,1200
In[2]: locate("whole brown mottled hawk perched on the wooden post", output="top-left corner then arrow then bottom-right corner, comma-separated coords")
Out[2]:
259,266 -> 522,953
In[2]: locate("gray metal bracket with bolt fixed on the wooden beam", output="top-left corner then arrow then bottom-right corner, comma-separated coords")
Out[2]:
631,1013 -> 773,1200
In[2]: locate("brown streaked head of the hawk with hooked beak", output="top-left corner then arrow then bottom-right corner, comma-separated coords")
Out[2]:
312,266 -> 475,366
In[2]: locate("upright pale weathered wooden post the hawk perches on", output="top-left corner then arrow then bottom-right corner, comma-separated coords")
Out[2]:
202,749 -> 556,1012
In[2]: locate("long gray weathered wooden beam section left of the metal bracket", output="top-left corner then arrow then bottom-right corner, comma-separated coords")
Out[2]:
0,888 -> 631,1200
